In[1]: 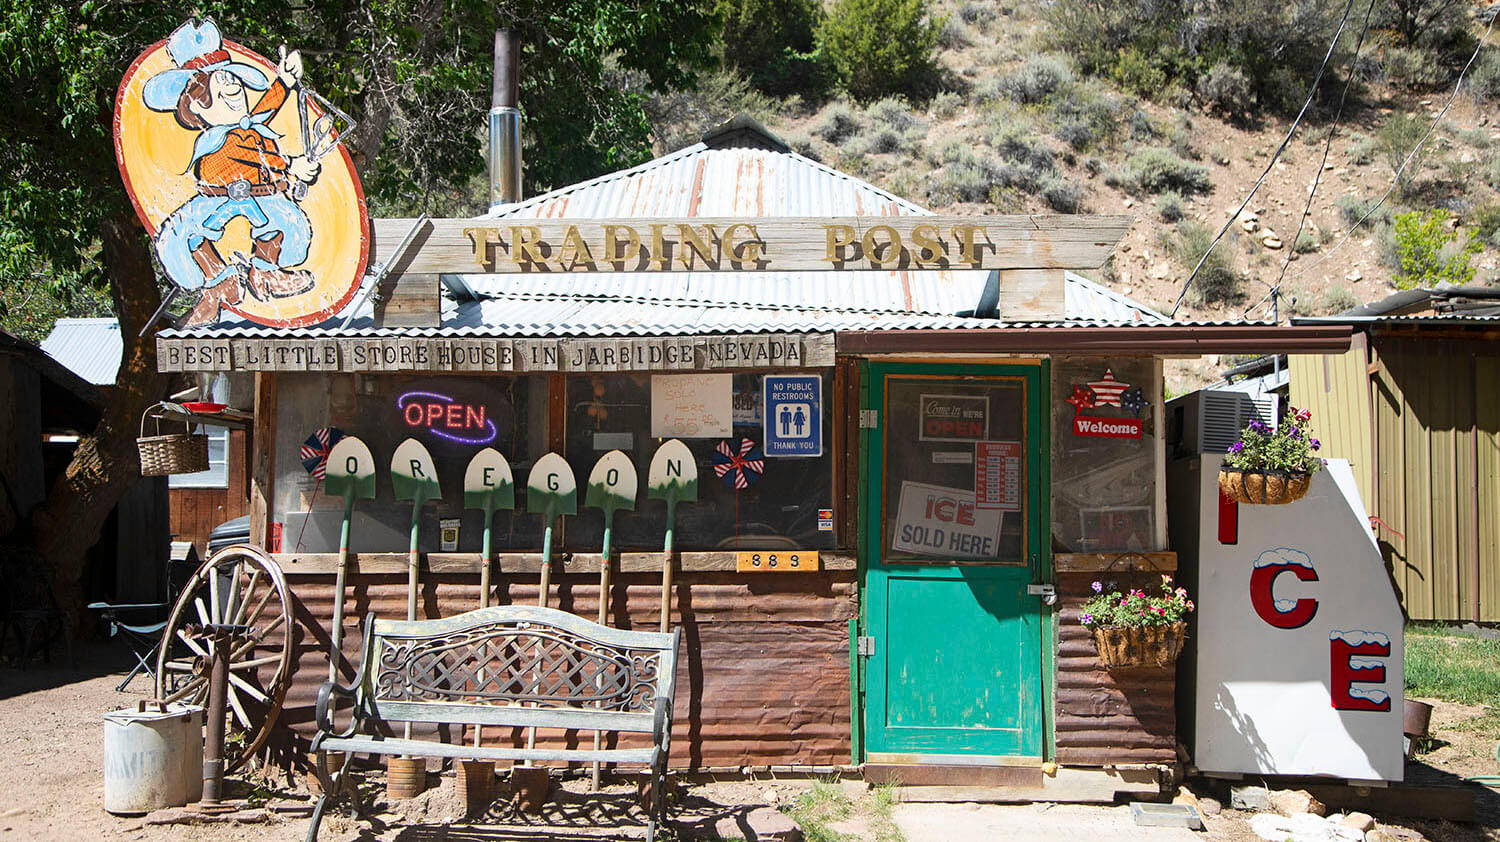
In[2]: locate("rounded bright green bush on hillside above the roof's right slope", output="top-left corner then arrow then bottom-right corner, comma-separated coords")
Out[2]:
818,0 -> 942,101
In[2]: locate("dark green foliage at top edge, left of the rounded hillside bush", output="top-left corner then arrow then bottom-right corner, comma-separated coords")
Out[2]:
717,0 -> 824,96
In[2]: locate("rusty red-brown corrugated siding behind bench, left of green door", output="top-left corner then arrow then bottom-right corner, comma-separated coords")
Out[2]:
282,572 -> 855,770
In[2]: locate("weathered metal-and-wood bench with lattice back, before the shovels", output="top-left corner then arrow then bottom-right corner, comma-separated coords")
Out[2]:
308,605 -> 681,842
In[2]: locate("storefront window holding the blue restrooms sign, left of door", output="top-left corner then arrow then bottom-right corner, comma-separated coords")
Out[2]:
564,372 -> 836,552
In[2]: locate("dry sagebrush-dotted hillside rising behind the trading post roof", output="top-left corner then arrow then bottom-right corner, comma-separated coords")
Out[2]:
653,0 -> 1500,351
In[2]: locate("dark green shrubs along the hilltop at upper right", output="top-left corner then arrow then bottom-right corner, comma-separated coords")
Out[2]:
1046,0 -> 1341,113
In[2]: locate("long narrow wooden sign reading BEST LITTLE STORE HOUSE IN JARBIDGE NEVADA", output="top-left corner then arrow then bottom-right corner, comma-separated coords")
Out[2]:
156,333 -> 834,372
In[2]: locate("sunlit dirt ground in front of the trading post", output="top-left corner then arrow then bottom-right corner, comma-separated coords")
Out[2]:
0,642 -> 1500,842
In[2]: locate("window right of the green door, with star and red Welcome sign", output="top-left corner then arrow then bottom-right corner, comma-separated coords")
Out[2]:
1052,357 -> 1161,552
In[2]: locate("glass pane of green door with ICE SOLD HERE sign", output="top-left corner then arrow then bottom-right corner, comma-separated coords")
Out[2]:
884,377 -> 1031,564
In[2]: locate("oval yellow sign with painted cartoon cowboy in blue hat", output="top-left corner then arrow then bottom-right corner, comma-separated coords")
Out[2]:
116,21 -> 368,327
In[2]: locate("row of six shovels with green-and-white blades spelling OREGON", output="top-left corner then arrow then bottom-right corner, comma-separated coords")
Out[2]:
324,435 -> 698,789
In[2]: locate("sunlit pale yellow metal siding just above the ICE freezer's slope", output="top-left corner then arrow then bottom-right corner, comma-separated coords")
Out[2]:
1287,338 -> 1376,509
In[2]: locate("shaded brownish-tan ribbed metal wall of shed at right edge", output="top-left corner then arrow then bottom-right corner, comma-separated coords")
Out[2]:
1373,341 -> 1500,621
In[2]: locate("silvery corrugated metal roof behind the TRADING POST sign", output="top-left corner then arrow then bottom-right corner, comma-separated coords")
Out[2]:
167,121 -> 1172,338
